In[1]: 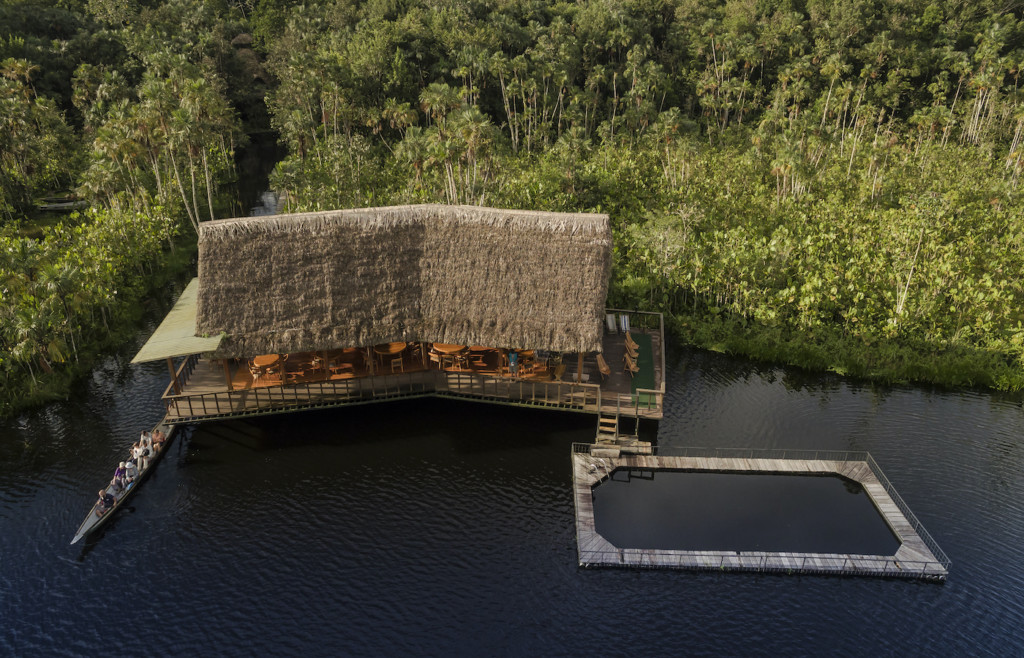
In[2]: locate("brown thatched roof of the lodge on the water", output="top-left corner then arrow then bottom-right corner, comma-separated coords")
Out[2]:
197,205 -> 611,356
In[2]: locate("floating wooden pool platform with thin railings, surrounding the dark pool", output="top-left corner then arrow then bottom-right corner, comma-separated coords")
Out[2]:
572,443 -> 950,581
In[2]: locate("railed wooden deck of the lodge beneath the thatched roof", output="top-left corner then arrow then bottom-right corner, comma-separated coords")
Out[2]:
163,313 -> 665,423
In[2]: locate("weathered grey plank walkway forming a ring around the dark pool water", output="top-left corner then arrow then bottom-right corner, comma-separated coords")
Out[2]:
572,452 -> 948,580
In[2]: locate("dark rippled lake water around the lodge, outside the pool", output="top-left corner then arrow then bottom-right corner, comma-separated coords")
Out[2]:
0,300 -> 1024,656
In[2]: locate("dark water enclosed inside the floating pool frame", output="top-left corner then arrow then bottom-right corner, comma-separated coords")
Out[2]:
594,469 -> 899,556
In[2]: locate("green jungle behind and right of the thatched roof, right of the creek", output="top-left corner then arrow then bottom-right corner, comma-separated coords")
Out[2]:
267,0 -> 1024,388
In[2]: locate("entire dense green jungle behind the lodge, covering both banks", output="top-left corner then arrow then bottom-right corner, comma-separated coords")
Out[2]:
6,0 -> 1024,415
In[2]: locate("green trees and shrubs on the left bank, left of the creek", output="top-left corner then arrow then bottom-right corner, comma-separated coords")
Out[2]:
0,0 -> 252,412
